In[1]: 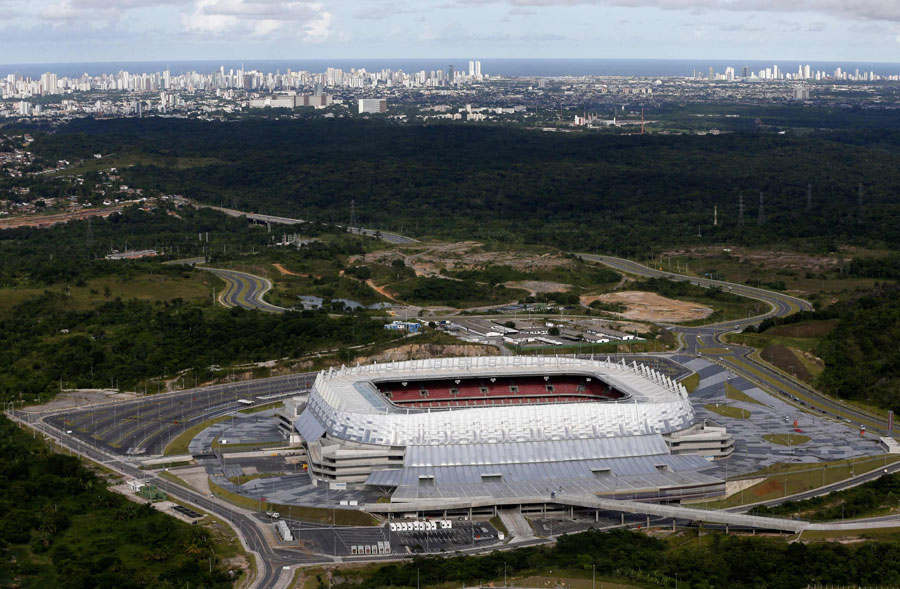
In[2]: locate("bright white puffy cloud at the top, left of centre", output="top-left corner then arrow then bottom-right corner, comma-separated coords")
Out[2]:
182,0 -> 332,43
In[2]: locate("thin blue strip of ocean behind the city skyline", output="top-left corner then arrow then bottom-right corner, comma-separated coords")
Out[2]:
0,58 -> 900,78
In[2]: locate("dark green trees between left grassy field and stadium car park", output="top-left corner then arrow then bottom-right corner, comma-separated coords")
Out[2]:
0,292 -> 396,401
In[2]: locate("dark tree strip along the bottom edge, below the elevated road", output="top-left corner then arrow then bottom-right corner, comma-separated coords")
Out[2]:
330,530 -> 900,589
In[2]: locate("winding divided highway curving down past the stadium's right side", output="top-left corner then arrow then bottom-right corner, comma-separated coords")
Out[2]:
578,254 -> 887,435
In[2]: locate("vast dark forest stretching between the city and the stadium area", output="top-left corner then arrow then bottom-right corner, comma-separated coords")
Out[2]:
24,119 -> 900,253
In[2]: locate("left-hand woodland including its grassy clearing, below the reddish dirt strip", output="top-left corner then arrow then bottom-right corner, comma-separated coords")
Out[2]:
0,207 -> 391,402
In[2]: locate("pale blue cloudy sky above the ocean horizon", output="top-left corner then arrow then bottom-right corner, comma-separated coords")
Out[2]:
0,0 -> 900,63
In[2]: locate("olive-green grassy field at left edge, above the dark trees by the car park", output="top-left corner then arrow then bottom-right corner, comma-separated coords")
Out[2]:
0,272 -> 214,312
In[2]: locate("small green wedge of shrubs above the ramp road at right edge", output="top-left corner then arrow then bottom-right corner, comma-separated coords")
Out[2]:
755,474 -> 900,521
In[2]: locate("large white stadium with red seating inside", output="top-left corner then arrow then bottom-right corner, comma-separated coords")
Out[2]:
282,356 -> 733,504
